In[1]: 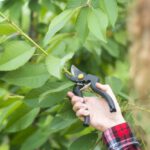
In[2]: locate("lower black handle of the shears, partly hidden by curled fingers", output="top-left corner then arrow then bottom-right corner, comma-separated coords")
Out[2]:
73,85 -> 90,127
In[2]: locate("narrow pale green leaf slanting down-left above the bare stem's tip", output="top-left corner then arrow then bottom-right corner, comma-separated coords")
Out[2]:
44,9 -> 74,45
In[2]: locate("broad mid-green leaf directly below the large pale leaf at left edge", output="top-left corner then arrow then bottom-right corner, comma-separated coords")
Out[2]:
3,63 -> 49,88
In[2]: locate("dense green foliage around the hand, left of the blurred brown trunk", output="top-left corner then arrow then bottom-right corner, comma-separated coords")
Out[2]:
0,0 -> 146,150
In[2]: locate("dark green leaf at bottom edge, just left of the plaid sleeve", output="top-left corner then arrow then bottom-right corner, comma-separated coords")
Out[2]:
69,133 -> 97,150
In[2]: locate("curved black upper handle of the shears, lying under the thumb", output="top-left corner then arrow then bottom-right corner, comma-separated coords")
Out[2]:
91,83 -> 117,112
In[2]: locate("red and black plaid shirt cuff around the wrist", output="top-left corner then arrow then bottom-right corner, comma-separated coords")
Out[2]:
102,123 -> 140,150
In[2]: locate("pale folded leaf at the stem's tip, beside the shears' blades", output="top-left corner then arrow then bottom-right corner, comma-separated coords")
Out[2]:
46,53 -> 73,79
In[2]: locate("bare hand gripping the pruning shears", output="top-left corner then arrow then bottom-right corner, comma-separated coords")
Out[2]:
67,83 -> 125,131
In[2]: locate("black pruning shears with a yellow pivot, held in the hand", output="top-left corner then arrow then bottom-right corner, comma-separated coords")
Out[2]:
66,65 -> 116,126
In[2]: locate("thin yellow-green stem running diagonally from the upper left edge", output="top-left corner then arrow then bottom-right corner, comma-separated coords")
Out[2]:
0,12 -> 48,55
